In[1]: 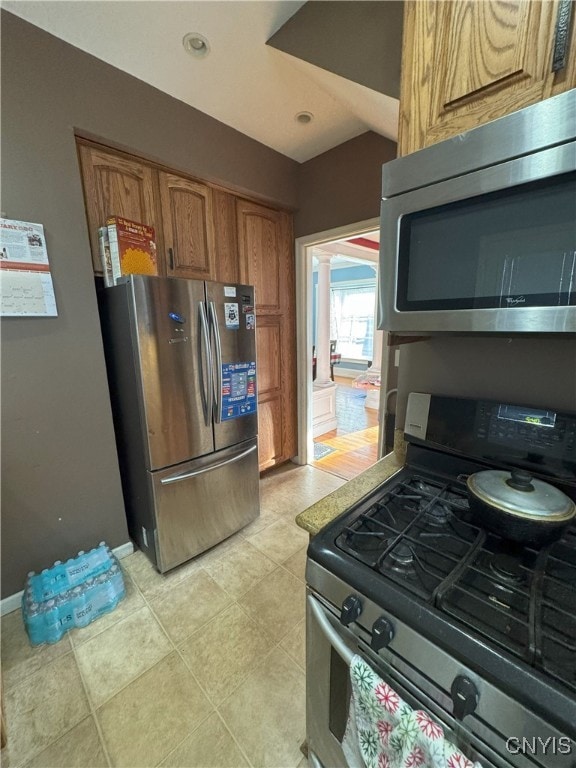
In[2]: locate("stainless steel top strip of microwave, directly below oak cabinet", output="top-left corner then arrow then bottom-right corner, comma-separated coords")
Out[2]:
382,90 -> 576,198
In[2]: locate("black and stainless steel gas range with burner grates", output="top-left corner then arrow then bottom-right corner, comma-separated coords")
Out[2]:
307,395 -> 576,768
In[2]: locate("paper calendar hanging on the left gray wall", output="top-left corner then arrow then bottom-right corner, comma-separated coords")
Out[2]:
0,219 -> 58,317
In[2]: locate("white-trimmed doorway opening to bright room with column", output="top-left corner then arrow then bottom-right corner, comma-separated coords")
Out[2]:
295,219 -> 388,479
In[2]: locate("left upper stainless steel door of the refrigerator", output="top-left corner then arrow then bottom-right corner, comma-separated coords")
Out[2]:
128,275 -> 214,470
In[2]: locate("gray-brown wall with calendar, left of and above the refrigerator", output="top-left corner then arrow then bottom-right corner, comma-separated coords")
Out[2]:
1,12 -> 298,597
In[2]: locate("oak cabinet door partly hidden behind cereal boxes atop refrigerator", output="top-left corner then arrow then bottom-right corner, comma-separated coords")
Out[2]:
78,144 -> 161,275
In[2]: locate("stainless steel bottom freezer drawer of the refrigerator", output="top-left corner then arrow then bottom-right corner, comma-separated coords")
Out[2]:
149,439 -> 260,573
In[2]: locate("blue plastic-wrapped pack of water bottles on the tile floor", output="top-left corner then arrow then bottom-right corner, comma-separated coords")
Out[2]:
22,542 -> 126,645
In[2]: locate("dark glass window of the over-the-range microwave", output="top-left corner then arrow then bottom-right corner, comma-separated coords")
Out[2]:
397,172 -> 576,311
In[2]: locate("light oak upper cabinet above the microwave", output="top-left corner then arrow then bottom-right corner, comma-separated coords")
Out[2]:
398,0 -> 576,155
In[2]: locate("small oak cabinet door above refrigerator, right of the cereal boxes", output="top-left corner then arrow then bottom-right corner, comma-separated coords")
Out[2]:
158,171 -> 216,280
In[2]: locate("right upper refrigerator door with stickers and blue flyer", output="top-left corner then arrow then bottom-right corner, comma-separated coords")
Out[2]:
206,282 -> 258,450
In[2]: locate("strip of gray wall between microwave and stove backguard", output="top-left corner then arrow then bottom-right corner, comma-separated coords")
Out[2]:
396,335 -> 576,427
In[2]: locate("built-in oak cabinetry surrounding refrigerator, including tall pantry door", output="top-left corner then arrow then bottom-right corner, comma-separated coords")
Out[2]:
78,140 -> 297,471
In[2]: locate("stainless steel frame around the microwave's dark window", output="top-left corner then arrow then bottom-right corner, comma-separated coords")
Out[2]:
378,143 -> 576,333
